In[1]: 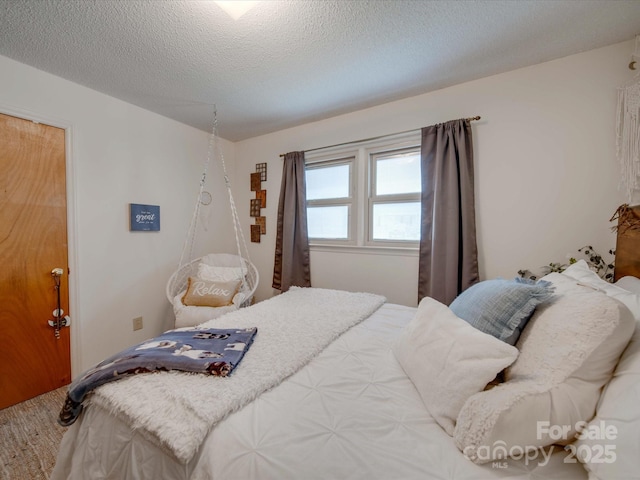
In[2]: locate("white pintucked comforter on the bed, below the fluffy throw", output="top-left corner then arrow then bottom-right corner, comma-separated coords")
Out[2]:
52,304 -> 586,480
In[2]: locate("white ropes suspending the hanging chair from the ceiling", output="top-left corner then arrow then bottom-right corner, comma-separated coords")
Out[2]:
178,107 -> 256,296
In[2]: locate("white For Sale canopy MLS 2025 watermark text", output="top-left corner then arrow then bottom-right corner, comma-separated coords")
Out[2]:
462,420 -> 618,468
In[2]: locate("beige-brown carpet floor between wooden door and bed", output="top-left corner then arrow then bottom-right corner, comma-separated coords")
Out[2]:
0,387 -> 67,480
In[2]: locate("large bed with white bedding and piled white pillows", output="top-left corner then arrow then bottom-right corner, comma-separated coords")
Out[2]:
51,262 -> 640,480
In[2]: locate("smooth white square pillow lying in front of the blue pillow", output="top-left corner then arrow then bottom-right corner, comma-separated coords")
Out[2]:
393,297 -> 518,435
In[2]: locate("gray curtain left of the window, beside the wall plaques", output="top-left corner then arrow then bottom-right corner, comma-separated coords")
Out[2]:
272,152 -> 311,292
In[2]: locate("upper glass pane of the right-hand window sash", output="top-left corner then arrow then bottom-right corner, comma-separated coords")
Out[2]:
376,152 -> 422,195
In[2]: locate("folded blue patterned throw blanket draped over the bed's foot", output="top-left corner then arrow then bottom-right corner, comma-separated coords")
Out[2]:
58,327 -> 258,427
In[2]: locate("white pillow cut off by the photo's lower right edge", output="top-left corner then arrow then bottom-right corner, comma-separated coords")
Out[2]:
568,322 -> 640,479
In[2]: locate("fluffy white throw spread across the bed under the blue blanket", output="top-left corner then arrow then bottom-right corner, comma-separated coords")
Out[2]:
84,287 -> 385,463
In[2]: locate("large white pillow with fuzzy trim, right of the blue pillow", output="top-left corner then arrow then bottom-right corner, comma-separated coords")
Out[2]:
454,290 -> 635,463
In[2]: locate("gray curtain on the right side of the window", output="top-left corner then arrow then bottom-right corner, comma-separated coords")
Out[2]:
418,120 -> 478,305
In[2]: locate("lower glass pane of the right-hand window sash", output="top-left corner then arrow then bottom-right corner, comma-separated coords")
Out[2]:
372,202 -> 420,241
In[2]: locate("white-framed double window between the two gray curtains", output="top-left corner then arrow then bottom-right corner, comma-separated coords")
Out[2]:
306,134 -> 421,249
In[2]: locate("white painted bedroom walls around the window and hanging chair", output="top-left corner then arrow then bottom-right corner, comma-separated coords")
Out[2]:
0,41 -> 633,375
